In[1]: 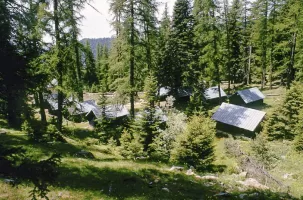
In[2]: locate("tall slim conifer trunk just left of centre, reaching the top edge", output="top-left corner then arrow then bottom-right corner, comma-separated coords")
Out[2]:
129,0 -> 135,118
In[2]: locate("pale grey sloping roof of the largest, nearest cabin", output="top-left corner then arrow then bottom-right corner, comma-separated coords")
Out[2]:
212,103 -> 266,131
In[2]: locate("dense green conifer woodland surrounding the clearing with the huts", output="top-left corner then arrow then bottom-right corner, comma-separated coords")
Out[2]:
0,0 -> 303,199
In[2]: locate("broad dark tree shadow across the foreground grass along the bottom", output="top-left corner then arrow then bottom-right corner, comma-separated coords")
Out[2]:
55,164 -> 295,200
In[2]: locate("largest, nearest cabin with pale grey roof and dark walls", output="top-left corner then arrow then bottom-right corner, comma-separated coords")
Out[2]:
212,103 -> 266,135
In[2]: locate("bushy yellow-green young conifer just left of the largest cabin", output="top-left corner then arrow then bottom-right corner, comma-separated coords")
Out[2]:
171,116 -> 216,169
